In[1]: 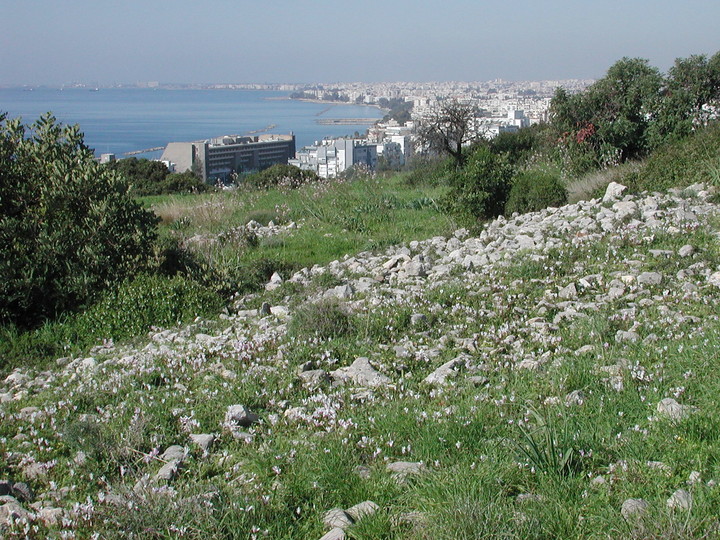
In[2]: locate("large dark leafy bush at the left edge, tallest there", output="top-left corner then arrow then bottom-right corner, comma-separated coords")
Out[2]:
0,114 -> 157,327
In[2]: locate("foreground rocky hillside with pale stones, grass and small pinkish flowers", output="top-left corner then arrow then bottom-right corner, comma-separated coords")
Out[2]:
0,184 -> 720,539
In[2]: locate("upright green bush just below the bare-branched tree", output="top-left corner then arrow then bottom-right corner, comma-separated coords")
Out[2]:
441,147 -> 512,222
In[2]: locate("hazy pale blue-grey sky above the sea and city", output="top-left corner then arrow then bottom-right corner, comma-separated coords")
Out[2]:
0,0 -> 720,85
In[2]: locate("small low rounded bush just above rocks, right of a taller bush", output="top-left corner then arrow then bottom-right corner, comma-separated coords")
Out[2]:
505,170 -> 567,215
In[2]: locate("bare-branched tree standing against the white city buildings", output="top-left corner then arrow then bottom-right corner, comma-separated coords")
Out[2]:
417,99 -> 480,169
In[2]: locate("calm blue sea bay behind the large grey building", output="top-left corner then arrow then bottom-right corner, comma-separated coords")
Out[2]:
0,88 -> 382,157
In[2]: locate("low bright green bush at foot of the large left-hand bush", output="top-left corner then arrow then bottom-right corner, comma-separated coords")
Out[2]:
74,274 -> 223,339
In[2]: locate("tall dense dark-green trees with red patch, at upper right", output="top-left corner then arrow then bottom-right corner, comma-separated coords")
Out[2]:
550,49 -> 720,174
